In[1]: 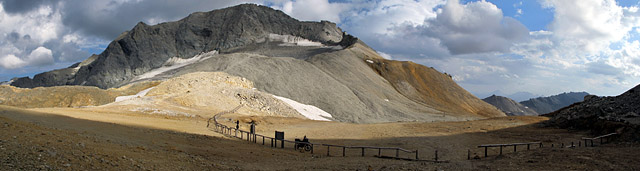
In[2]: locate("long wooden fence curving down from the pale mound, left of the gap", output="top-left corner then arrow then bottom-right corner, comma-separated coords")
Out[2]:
207,105 -> 438,162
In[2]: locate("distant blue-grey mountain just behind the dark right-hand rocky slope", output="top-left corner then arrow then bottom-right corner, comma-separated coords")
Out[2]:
520,92 -> 589,114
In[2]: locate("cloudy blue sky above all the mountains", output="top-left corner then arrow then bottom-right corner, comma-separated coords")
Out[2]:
0,0 -> 640,98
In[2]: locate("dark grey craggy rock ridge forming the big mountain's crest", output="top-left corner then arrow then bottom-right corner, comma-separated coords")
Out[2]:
11,4 -> 342,88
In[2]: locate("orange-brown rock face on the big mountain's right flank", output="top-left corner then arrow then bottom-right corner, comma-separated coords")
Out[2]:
366,59 -> 505,117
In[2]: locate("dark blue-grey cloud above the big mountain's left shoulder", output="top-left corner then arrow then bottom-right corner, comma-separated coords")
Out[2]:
61,0 -> 258,40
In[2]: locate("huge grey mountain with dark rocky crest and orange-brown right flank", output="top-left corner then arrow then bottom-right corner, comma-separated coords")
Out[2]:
5,4 -> 505,123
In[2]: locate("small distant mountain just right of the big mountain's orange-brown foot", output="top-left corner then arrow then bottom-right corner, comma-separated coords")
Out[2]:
482,95 -> 538,116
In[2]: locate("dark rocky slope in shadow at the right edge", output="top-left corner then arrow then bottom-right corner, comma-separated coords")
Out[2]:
547,85 -> 640,141
